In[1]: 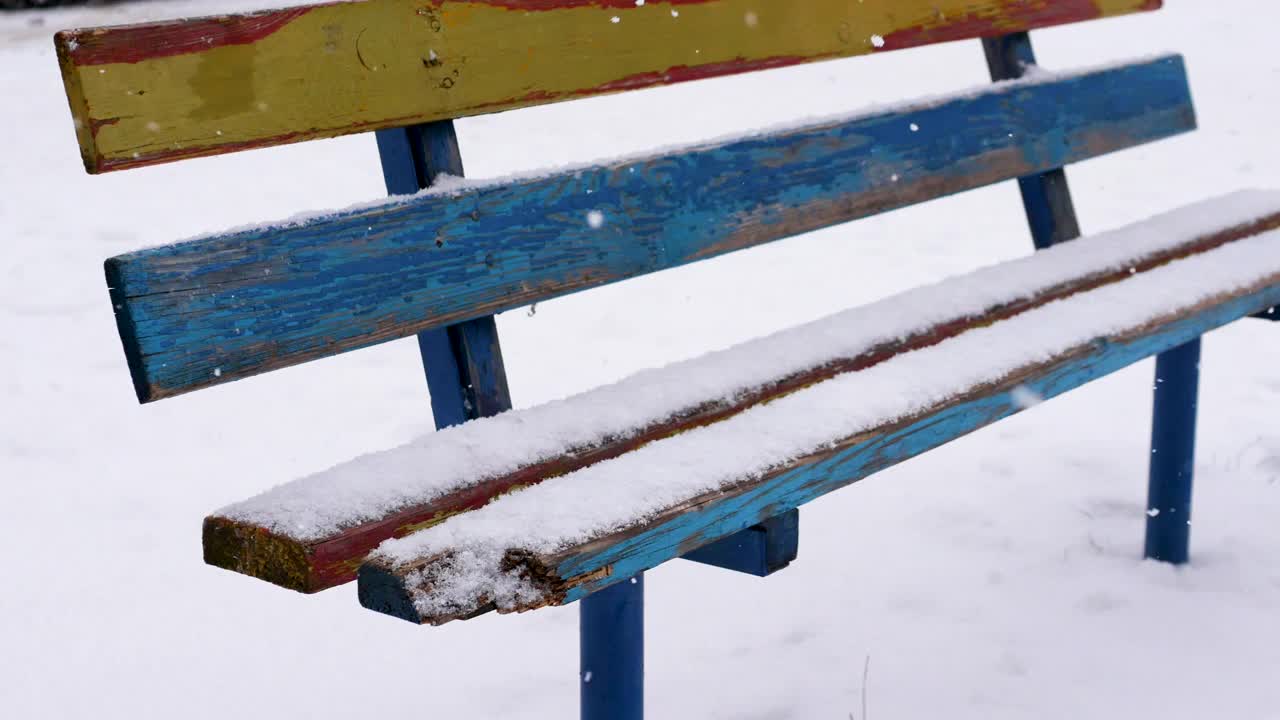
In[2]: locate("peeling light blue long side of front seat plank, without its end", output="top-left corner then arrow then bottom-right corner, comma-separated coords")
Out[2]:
548,283 -> 1280,602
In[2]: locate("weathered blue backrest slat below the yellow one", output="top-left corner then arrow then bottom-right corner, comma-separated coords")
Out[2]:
106,58 -> 1196,402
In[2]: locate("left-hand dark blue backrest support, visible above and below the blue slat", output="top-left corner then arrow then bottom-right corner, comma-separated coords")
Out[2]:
375,120 -> 511,429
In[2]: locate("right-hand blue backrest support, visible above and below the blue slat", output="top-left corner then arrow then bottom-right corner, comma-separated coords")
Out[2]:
982,32 -> 1080,250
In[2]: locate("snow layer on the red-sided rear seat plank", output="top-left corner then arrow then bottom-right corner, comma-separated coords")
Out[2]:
216,191 -> 1280,542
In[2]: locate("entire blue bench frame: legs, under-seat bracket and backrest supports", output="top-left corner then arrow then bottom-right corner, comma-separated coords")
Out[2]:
376,32 -> 1201,720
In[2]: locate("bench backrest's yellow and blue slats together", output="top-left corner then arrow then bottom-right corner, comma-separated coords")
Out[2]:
58,0 -> 1177,402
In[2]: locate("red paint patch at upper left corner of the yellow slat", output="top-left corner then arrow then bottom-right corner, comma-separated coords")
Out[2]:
58,5 -> 321,67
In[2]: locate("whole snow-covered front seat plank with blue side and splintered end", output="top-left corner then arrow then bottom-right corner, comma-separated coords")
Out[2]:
360,193 -> 1280,624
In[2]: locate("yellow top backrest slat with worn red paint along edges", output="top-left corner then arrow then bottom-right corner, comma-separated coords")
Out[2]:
56,0 -> 1161,173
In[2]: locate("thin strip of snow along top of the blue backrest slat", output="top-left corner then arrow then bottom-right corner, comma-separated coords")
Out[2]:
142,53 -> 1178,249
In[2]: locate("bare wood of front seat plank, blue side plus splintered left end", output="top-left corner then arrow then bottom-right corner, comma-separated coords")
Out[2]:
358,274 -> 1280,624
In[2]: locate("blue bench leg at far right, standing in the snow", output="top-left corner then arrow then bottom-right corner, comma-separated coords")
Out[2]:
1146,338 -> 1201,565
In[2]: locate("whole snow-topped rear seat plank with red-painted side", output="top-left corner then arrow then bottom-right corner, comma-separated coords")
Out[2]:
204,192 -> 1280,592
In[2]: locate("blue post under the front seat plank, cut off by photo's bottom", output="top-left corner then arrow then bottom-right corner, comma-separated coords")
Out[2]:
579,574 -> 644,720
